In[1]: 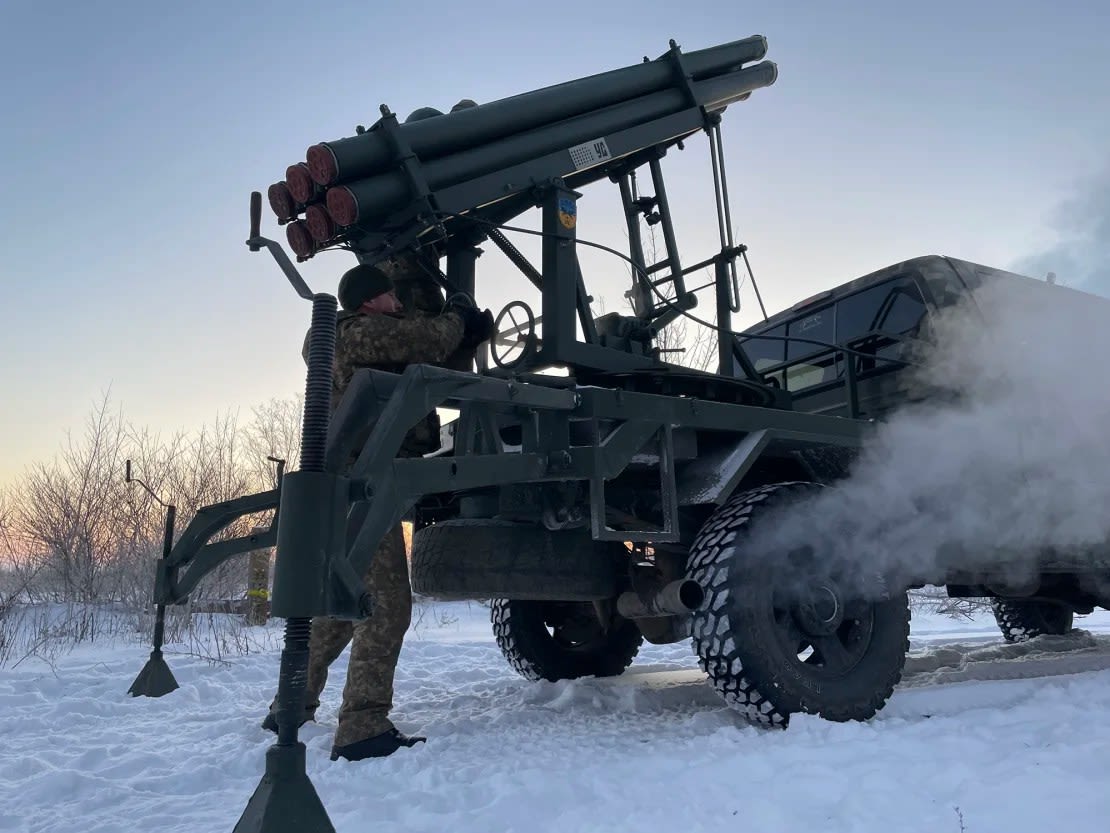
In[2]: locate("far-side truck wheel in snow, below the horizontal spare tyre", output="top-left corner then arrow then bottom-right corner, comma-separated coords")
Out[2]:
490,599 -> 644,682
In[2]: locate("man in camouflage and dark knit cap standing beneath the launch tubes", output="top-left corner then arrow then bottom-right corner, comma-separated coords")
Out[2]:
262,255 -> 493,761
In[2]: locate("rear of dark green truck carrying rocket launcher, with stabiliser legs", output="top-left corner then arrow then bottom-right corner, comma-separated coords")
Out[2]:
123,36 -> 1101,833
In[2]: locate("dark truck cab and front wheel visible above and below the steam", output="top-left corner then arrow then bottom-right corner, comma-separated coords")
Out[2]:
739,255 -> 1110,642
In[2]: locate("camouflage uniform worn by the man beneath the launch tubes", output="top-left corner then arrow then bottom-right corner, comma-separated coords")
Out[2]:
271,261 -> 474,746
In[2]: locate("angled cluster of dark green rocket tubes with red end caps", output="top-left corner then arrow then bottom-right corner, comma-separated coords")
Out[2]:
269,36 -> 777,261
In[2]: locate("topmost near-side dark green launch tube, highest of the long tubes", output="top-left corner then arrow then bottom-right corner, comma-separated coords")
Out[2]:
307,34 -> 767,185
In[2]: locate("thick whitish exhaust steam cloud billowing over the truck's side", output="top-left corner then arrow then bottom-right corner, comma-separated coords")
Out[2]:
751,247 -> 1110,599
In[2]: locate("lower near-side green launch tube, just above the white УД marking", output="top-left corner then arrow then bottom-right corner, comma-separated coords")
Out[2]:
326,61 -> 777,225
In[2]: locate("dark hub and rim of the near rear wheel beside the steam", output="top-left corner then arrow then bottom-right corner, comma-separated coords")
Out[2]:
769,580 -> 875,679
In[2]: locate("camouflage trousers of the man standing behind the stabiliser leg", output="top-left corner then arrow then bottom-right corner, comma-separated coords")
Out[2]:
304,526 -> 413,746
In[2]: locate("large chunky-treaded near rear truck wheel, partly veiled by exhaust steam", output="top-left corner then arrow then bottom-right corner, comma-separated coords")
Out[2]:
687,483 -> 910,726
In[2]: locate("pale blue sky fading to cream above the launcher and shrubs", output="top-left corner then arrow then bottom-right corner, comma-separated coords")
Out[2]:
0,0 -> 1110,484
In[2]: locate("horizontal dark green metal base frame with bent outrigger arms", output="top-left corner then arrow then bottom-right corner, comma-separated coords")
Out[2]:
155,364 -> 867,618
